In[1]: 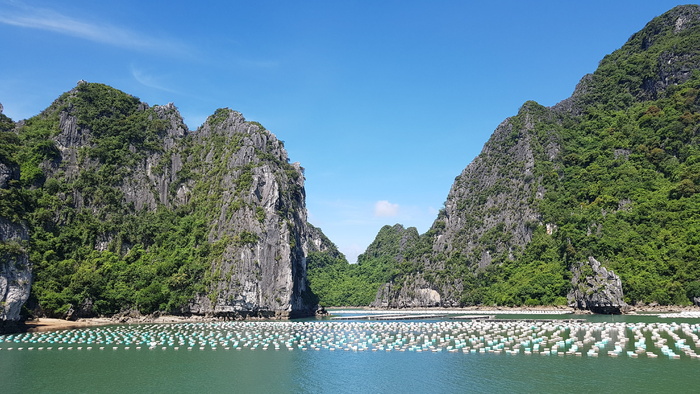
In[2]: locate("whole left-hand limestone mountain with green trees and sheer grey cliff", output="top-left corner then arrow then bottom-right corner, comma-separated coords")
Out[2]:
3,81 -> 328,317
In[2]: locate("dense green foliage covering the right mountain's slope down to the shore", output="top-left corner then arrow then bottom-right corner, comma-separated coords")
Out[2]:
356,74 -> 700,306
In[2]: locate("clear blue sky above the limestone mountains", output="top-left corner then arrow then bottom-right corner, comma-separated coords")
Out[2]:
0,0 -> 682,261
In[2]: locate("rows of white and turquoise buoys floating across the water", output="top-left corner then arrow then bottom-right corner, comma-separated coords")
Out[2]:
0,321 -> 700,359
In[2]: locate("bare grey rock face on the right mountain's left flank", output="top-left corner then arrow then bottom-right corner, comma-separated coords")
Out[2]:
368,102 -> 559,307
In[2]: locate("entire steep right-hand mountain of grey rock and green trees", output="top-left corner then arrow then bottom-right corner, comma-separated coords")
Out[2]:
374,5 -> 700,307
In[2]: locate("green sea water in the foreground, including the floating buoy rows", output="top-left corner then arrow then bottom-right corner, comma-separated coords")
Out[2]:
0,316 -> 700,393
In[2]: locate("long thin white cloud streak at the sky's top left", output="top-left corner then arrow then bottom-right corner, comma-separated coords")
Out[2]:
0,6 -> 185,54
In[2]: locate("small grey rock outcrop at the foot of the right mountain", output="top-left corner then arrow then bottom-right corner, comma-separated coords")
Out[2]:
567,257 -> 629,315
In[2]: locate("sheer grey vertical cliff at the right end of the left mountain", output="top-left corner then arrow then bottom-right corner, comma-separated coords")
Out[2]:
187,110 -> 317,317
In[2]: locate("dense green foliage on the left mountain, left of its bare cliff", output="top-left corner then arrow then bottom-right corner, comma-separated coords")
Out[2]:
2,84 -> 215,316
